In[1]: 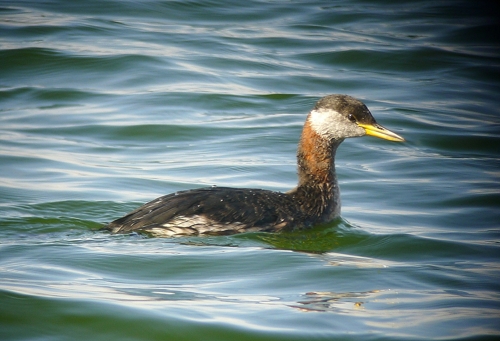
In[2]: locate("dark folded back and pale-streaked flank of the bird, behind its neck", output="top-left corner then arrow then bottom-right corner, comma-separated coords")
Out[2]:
105,187 -> 300,236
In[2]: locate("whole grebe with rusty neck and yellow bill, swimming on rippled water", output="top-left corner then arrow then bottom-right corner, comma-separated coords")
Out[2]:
105,95 -> 403,237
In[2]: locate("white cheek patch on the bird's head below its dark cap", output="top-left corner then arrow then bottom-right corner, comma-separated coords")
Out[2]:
309,109 -> 366,140
